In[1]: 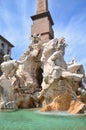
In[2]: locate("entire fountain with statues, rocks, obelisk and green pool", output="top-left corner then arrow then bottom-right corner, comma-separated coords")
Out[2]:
0,0 -> 86,130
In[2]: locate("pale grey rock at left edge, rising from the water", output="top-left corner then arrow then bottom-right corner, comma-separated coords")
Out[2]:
0,75 -> 17,109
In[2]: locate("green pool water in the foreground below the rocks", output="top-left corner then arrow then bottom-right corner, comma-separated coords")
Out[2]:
0,109 -> 86,130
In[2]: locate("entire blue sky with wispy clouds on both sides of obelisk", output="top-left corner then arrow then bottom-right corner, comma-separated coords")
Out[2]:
0,0 -> 86,70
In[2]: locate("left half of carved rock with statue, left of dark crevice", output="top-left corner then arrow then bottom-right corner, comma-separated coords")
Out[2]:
0,37 -> 42,109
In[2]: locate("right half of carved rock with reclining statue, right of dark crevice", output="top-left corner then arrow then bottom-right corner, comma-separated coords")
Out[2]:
40,38 -> 84,112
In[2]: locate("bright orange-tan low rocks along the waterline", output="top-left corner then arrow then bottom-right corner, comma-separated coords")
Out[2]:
41,99 -> 85,114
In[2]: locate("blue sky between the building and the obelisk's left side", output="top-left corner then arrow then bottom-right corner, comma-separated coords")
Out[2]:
0,0 -> 31,59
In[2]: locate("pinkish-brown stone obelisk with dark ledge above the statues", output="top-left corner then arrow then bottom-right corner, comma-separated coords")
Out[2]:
31,0 -> 54,41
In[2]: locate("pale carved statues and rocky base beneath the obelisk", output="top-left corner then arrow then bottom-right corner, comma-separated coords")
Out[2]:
0,36 -> 86,114
